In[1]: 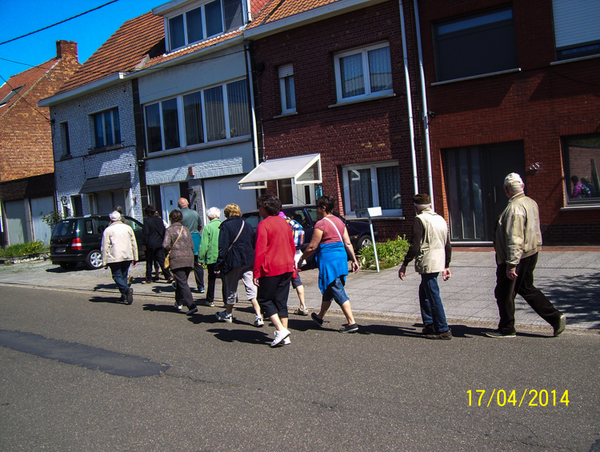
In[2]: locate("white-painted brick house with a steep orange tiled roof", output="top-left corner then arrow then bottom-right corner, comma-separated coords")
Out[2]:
40,12 -> 164,220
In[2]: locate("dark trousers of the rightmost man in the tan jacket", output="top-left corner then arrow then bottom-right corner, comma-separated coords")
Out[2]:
494,253 -> 561,334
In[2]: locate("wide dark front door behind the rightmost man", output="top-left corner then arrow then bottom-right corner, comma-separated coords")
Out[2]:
444,142 -> 525,242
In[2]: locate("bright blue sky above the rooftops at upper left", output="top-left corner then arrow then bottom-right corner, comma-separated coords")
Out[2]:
0,0 -> 162,81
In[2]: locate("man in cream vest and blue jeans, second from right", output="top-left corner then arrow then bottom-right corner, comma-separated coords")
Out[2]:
398,194 -> 452,340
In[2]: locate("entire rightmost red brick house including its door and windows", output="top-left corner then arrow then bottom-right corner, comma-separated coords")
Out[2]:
418,0 -> 600,245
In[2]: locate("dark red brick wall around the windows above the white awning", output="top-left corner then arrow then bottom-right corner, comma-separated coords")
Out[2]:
254,1 -> 424,239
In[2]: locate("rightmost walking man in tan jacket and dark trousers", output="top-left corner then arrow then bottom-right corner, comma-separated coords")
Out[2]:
486,173 -> 567,338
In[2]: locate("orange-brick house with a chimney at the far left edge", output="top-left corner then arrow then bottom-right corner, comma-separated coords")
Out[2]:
0,41 -> 80,245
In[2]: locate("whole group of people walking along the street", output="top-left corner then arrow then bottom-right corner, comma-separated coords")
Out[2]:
102,173 -> 566,347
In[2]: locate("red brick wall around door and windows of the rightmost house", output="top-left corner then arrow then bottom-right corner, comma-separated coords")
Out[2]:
419,0 -> 600,245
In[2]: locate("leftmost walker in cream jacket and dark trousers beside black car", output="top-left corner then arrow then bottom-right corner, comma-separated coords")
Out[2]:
102,210 -> 138,304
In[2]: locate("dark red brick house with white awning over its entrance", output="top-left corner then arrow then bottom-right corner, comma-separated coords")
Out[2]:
241,0 -> 427,240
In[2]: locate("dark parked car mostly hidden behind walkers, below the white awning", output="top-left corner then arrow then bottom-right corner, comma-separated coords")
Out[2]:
242,206 -> 377,252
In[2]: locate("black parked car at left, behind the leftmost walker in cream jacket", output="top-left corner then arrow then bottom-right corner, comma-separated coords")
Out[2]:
50,215 -> 144,270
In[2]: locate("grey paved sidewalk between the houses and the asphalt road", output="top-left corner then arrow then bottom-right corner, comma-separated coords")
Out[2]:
0,247 -> 600,329
